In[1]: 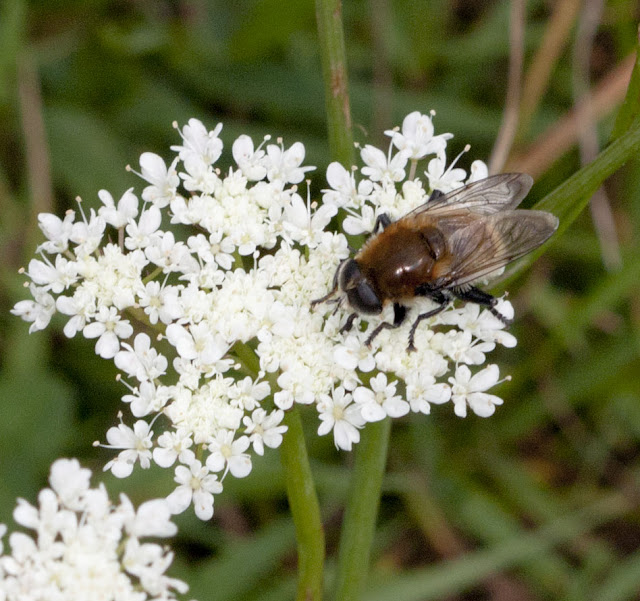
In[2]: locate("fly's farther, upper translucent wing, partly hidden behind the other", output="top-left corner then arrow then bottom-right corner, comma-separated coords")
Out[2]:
404,173 -> 533,218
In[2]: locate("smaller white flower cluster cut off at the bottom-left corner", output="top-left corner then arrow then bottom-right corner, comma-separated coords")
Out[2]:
0,459 -> 188,601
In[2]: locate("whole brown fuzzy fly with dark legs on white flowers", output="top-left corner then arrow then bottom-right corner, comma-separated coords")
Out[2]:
312,173 -> 558,351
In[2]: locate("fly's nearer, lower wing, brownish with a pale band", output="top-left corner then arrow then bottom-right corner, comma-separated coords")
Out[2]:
439,210 -> 558,288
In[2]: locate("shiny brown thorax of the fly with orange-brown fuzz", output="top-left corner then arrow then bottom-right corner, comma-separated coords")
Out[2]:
355,221 -> 450,302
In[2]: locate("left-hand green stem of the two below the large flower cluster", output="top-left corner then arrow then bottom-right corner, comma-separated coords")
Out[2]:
280,406 -> 324,601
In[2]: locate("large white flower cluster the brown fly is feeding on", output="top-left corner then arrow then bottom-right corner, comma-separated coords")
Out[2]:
13,113 -> 515,519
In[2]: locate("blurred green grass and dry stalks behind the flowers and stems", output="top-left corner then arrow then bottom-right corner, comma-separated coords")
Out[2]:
0,0 -> 640,601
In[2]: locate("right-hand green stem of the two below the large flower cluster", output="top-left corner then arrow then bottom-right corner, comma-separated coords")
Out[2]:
334,417 -> 391,601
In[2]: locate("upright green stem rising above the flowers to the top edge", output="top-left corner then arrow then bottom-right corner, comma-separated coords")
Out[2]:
316,0 -> 354,169
